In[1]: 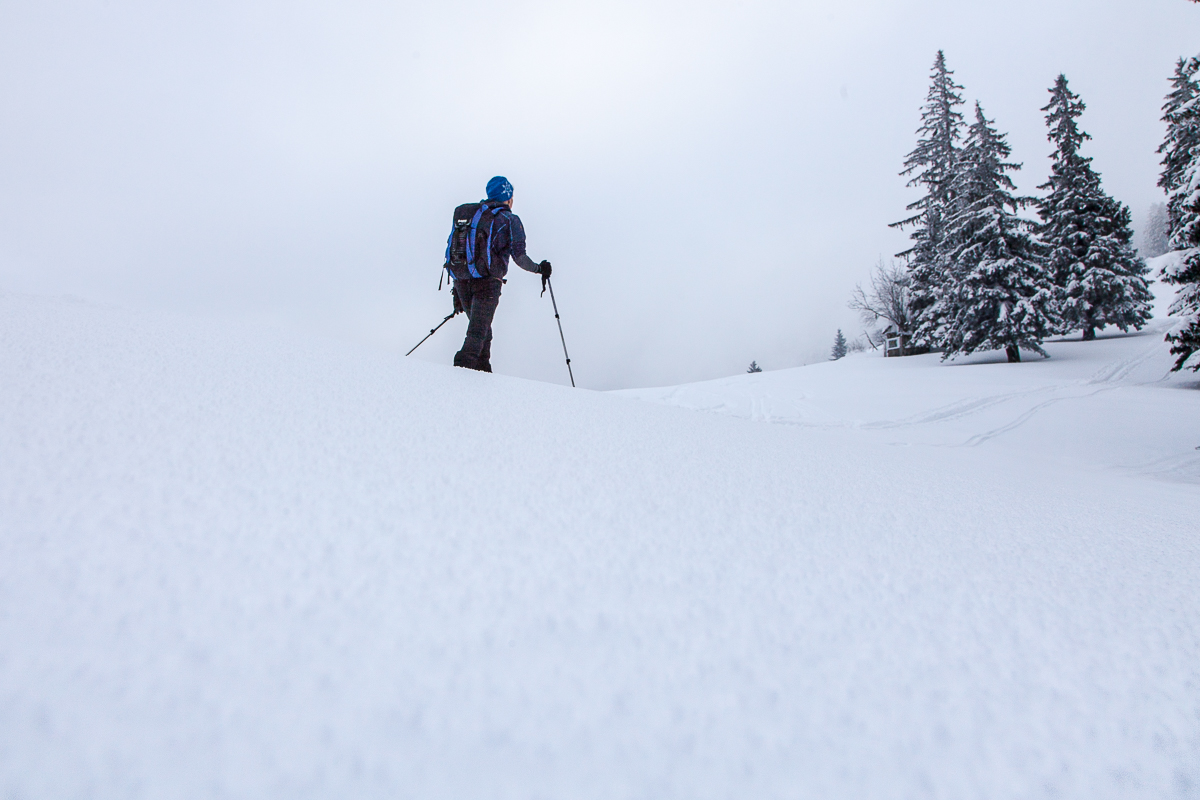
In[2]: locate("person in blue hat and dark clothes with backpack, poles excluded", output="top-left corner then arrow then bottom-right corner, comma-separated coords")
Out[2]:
445,175 -> 550,372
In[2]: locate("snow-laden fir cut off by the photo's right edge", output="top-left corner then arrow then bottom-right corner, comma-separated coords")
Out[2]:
1158,56 -> 1200,369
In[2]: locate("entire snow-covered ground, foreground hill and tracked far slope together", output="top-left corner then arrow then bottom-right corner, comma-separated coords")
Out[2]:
0,291 -> 1200,800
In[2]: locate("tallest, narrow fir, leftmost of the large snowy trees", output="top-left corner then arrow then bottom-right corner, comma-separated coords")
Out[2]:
892,50 -> 965,338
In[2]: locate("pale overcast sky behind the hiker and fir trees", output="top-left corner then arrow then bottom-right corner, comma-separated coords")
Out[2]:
7,0 -> 1200,389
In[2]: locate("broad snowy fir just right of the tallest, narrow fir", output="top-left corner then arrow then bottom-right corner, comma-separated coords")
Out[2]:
918,103 -> 1058,361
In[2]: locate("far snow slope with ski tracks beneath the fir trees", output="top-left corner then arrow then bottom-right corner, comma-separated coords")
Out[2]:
619,320 -> 1200,483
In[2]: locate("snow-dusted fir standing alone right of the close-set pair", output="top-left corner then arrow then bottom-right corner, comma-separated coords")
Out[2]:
1038,74 -> 1152,339
